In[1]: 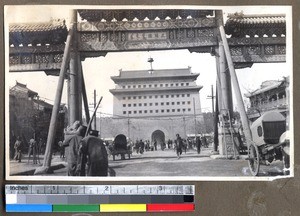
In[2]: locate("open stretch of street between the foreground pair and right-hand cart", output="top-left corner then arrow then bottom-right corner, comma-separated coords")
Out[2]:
110,149 -> 247,176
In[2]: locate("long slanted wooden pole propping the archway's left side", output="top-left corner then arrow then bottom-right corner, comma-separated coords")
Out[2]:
34,25 -> 74,175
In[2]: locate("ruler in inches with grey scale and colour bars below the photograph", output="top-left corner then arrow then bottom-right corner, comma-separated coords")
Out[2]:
5,185 -> 195,212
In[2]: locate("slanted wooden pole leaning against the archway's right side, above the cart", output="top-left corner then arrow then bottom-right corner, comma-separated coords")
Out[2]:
219,26 -> 252,146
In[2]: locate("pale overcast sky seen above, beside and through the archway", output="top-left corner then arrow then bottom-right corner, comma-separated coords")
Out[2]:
5,5 -> 292,113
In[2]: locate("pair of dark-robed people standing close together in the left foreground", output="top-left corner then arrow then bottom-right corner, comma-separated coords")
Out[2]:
63,121 -> 108,176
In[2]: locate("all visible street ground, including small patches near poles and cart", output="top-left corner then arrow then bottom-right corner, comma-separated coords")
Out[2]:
11,147 -> 282,177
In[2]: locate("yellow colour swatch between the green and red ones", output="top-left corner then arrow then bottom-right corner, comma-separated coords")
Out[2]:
100,204 -> 147,212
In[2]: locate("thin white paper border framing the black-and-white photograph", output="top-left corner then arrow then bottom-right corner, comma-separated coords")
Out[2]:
4,4 -> 294,182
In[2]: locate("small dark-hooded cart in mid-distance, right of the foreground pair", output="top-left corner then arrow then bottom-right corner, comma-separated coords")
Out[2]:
109,134 -> 132,160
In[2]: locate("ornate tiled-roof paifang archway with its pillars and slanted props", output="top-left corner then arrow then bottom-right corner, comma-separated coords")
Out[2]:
9,9 -> 286,174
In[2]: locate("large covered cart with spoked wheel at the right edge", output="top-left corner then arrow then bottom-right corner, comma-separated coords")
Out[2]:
248,111 -> 290,176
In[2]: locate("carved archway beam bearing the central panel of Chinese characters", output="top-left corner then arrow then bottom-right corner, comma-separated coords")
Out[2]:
78,29 -> 217,52
